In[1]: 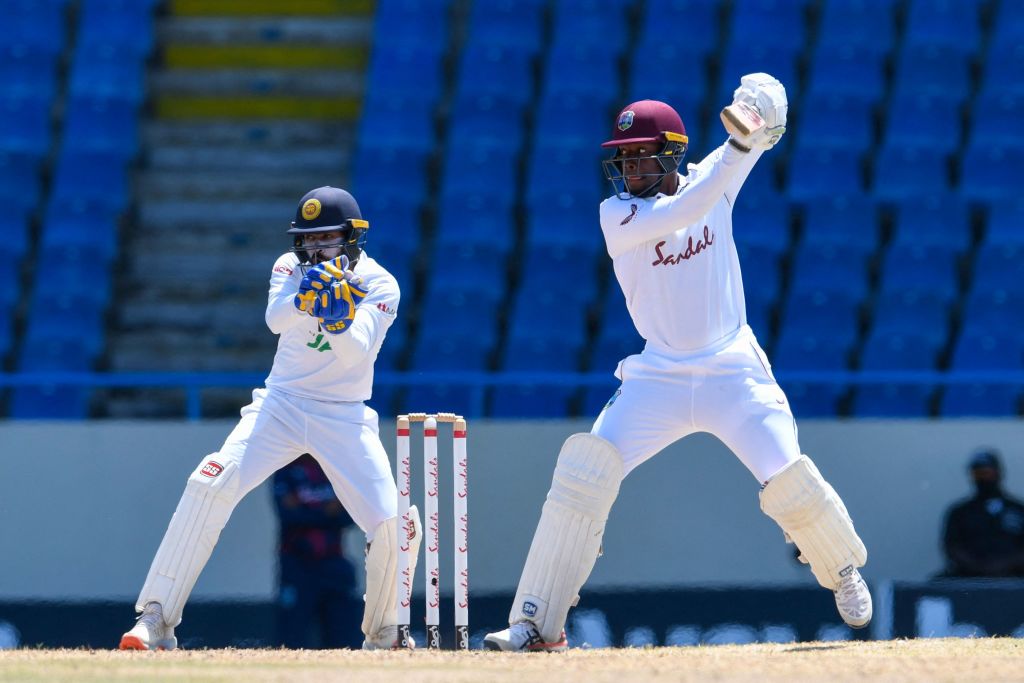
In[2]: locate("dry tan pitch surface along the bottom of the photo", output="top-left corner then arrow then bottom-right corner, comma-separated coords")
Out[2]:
0,638 -> 1024,683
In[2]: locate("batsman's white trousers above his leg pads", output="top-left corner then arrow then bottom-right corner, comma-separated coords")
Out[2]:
591,325 -> 800,484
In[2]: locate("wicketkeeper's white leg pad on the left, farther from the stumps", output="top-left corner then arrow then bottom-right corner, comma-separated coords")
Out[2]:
135,454 -> 239,627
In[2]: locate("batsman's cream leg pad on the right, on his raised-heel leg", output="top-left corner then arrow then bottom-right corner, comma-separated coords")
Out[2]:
761,456 -> 867,590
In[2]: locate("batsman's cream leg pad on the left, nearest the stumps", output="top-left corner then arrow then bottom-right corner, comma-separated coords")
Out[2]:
509,434 -> 624,642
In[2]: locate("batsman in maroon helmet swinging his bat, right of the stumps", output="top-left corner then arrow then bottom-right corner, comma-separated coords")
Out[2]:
484,74 -> 871,651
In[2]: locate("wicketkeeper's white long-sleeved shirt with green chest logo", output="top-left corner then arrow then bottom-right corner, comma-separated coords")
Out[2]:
266,252 -> 399,401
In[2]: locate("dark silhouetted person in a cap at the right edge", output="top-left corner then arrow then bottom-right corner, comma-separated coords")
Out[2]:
943,451 -> 1024,578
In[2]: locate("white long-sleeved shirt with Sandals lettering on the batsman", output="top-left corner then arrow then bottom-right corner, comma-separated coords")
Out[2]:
600,143 -> 763,354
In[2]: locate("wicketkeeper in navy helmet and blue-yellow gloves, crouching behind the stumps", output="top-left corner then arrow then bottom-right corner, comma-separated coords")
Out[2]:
120,186 -> 422,650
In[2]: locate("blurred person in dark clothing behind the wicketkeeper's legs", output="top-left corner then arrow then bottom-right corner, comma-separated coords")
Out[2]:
273,455 -> 362,649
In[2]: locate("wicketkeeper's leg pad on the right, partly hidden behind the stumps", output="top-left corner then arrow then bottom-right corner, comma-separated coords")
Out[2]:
362,505 -> 423,638
